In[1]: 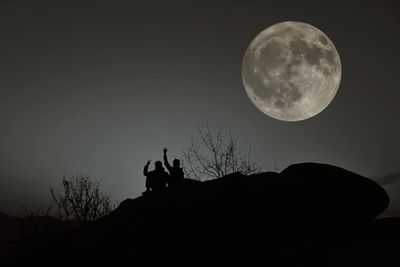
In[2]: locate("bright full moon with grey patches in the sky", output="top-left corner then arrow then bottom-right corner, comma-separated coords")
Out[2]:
242,21 -> 342,121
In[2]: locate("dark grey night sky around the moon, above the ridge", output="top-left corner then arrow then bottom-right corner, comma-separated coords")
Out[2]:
0,0 -> 400,214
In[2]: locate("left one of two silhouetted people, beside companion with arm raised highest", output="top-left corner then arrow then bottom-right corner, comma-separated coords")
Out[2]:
143,160 -> 169,193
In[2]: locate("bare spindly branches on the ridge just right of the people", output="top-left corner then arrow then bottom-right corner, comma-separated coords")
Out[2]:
183,126 -> 262,180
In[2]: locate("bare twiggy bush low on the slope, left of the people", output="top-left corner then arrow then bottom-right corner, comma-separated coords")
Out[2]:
50,174 -> 113,225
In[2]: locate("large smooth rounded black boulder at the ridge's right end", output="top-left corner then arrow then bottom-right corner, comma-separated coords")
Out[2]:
280,163 -> 389,224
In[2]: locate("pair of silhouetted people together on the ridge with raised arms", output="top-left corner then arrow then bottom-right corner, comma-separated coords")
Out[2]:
143,147 -> 184,193
